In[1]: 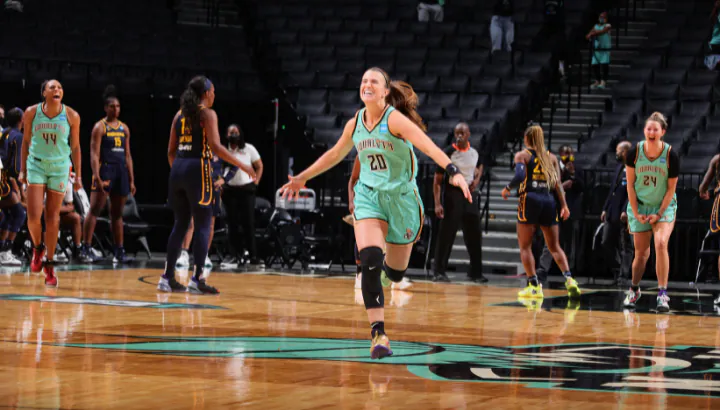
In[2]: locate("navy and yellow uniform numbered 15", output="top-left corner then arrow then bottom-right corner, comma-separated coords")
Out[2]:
92,120 -> 130,196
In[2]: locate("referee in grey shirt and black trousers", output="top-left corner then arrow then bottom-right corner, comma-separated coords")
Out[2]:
433,122 -> 487,283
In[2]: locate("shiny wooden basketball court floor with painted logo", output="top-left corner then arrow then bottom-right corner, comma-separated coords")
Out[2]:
0,269 -> 720,409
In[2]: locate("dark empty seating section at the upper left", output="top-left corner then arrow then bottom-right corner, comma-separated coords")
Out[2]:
0,0 -> 264,100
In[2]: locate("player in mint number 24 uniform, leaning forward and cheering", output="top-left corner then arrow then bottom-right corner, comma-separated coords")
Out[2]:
623,112 -> 680,312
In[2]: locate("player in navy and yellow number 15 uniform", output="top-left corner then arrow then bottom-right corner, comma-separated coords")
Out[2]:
80,85 -> 135,263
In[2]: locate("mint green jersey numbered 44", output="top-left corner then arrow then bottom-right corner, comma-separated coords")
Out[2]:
30,103 -> 72,161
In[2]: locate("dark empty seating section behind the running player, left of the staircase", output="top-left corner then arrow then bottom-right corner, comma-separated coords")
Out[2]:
256,0 -> 587,162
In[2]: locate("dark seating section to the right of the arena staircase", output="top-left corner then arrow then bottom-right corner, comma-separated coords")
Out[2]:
580,2 -> 720,218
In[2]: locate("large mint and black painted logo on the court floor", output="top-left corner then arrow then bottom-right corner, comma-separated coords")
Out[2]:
55,335 -> 720,397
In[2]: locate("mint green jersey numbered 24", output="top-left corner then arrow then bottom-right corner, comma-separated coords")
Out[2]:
635,141 -> 671,206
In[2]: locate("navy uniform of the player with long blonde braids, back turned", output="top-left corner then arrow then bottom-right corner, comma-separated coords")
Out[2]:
518,149 -> 558,226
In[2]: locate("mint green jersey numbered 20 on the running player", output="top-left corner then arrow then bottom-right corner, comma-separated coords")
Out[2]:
353,106 -> 417,192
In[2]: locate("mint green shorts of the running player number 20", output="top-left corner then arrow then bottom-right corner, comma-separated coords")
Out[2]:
353,182 -> 425,245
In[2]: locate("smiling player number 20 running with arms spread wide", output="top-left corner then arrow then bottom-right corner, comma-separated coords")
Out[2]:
281,67 -> 472,359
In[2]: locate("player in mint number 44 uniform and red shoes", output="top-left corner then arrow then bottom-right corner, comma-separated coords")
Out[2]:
18,80 -> 82,287
